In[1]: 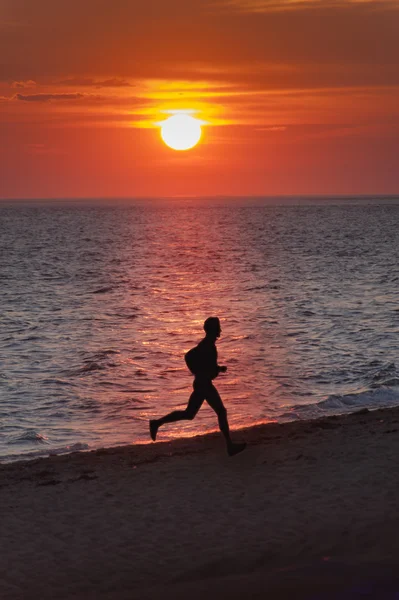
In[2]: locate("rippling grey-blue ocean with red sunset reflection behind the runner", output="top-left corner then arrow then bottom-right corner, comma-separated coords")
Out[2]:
0,198 -> 399,461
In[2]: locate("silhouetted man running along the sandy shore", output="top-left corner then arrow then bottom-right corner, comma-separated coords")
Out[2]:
150,317 -> 246,456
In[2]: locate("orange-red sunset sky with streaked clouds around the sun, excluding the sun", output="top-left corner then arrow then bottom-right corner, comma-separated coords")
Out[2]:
0,0 -> 399,198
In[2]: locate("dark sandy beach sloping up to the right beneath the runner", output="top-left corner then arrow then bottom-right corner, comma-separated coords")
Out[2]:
0,409 -> 399,600
